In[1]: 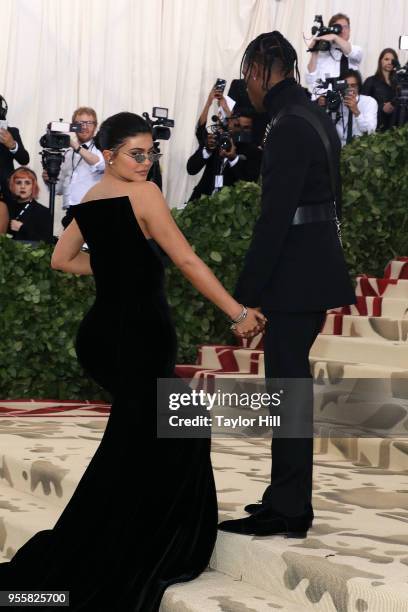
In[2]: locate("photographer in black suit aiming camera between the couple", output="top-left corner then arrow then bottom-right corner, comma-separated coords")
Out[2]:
187,109 -> 262,202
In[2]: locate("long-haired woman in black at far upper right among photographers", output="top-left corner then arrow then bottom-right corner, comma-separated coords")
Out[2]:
361,48 -> 399,132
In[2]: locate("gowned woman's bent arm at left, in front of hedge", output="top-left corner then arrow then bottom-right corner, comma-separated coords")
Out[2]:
51,220 -> 93,274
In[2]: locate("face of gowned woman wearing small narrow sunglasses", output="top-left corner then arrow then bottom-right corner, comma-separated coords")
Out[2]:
103,134 -> 155,183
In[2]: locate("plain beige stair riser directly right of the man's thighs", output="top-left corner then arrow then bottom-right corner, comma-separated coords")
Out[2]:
310,334 -> 408,369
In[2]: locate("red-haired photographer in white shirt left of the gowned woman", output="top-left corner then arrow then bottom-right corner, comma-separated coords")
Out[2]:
42,106 -> 105,228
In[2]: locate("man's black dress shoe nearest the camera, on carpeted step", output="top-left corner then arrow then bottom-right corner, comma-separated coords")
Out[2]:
218,510 -> 312,538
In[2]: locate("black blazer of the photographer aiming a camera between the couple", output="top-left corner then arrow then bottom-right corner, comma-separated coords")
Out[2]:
187,143 -> 262,202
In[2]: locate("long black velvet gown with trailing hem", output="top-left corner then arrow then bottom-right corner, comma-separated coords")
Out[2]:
0,196 -> 217,612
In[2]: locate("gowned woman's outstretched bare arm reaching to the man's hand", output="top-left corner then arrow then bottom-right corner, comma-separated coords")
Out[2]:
130,182 -> 260,332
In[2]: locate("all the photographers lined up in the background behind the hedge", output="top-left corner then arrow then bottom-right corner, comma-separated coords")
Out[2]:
0,13 -> 408,242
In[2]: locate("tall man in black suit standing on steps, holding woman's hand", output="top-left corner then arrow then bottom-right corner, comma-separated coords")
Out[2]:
219,32 -> 355,537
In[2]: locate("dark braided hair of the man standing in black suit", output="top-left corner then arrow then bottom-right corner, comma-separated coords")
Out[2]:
241,30 -> 300,89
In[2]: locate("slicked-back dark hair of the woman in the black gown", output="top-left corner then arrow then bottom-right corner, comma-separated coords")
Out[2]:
94,112 -> 152,151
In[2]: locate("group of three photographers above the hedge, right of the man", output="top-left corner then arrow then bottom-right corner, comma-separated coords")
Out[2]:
306,13 -> 406,145
